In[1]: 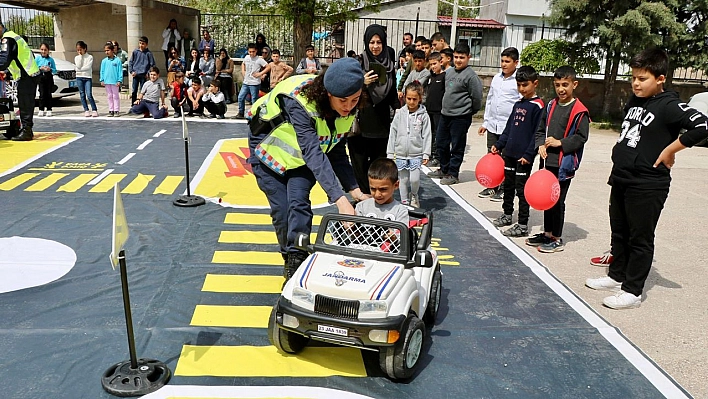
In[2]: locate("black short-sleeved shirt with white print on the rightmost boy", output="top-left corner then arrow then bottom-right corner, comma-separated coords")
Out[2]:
608,91 -> 708,189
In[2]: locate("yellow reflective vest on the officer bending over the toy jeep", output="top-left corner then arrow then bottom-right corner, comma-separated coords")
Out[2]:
248,75 -> 355,175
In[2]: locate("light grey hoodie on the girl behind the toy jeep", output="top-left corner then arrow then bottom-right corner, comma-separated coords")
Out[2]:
386,104 -> 431,159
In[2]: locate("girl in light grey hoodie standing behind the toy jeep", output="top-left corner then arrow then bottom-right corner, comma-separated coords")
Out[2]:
386,82 -> 431,208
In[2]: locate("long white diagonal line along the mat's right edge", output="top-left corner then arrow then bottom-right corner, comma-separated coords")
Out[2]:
423,169 -> 690,399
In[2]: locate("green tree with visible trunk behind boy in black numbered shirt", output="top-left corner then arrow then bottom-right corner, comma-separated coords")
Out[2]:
549,0 -> 686,116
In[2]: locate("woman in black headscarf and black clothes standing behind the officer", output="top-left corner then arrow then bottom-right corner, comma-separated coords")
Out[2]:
347,24 -> 400,194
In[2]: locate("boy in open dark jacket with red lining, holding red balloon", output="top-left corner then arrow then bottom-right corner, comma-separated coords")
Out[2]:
526,65 -> 590,253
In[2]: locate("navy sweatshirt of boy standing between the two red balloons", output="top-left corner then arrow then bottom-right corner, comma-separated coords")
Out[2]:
494,97 -> 543,163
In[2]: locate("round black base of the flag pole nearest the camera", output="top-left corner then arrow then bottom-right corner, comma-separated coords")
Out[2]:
101,359 -> 172,397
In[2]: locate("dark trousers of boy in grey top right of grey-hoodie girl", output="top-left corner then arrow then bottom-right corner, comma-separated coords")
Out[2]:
436,114 -> 472,178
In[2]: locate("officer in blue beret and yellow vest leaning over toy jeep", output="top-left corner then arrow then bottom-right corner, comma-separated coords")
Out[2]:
248,58 -> 369,281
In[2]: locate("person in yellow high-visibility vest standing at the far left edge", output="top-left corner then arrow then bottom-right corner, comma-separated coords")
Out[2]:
0,21 -> 40,141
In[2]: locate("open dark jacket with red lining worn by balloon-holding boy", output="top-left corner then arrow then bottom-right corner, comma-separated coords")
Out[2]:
536,98 -> 590,181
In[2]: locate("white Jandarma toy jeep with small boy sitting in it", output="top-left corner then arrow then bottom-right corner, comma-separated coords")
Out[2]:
268,211 -> 442,380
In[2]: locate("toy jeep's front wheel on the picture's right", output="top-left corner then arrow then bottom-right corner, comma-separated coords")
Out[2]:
379,316 -> 425,380
